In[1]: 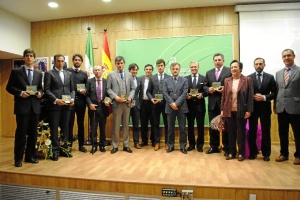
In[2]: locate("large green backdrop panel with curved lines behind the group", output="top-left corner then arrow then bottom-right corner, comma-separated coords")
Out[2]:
117,34 -> 233,125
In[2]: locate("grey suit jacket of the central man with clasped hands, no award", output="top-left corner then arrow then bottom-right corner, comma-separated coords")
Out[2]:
163,76 -> 189,114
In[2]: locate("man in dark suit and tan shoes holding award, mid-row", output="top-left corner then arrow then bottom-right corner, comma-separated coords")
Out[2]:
147,59 -> 171,150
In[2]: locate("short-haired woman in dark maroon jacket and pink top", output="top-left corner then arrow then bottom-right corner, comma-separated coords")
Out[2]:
221,60 -> 253,161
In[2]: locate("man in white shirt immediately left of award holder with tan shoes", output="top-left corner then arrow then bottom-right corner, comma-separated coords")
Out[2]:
139,64 -> 155,148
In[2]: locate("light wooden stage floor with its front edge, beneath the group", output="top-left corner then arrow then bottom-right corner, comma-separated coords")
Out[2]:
0,138 -> 300,199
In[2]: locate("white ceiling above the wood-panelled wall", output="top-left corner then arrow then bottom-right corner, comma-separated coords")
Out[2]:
0,0 -> 297,22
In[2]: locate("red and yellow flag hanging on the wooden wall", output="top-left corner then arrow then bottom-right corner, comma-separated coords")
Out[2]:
102,30 -> 112,78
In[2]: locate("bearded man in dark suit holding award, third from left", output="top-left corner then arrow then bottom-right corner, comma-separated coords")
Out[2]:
66,54 -> 88,153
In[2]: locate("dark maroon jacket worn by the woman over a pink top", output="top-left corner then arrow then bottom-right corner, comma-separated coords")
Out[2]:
221,75 -> 254,118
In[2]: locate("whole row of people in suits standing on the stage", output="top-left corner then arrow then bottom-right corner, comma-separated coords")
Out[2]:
6,49 -> 300,167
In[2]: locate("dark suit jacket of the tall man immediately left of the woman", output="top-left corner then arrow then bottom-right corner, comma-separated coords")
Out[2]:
205,66 -> 231,110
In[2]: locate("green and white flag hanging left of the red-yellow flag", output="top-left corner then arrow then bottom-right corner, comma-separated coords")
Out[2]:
84,27 -> 94,75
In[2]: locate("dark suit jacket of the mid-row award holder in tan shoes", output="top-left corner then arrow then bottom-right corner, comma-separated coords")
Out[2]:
147,73 -> 172,100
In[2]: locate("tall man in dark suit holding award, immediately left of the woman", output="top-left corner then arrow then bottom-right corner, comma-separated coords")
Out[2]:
205,53 -> 231,156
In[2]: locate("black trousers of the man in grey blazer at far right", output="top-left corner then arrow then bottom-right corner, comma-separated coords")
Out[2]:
278,111 -> 300,158
